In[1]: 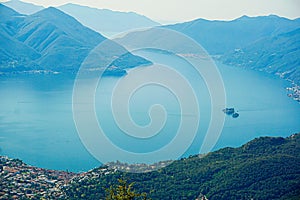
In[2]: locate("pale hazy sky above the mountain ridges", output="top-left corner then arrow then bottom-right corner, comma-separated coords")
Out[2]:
0,0 -> 300,22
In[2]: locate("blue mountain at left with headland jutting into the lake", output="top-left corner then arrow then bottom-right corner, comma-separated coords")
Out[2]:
0,4 -> 149,75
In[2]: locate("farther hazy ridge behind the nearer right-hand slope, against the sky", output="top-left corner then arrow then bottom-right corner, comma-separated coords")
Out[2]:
164,15 -> 300,55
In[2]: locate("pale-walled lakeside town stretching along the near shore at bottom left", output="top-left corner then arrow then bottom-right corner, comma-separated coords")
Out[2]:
0,156 -> 172,199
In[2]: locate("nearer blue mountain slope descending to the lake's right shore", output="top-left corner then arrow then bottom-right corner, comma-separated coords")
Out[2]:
222,28 -> 300,85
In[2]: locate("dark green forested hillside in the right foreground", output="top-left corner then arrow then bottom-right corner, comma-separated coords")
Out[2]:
65,134 -> 300,200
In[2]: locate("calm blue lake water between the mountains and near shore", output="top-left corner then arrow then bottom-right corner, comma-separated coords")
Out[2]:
0,52 -> 300,171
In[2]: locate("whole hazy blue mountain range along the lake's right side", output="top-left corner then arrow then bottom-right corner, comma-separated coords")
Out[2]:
118,15 -> 300,85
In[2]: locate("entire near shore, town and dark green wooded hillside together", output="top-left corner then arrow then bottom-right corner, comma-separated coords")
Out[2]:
0,134 -> 300,200
